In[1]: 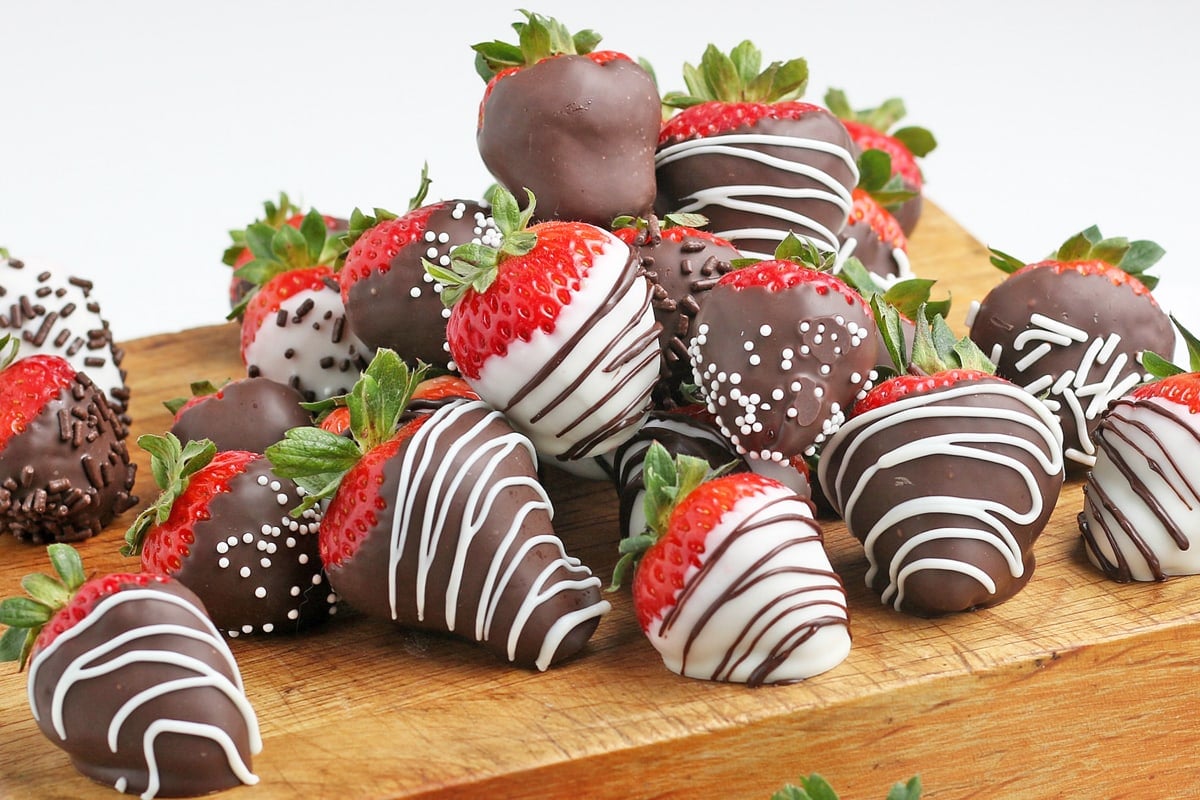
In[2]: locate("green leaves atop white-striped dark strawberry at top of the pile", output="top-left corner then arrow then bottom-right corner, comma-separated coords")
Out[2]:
662,40 -> 809,108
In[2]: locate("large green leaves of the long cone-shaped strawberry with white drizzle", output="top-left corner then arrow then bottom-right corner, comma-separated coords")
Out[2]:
264,348 -> 426,516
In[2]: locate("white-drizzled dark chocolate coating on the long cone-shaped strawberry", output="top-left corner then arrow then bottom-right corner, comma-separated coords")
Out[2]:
326,401 -> 610,669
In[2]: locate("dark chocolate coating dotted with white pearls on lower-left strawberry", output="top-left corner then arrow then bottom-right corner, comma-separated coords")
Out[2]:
174,458 -> 337,637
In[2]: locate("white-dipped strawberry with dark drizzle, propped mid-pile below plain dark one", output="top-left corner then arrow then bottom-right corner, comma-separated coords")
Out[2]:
426,191 -> 660,469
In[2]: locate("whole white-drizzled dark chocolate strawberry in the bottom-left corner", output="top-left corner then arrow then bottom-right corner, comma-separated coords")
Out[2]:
0,545 -> 263,799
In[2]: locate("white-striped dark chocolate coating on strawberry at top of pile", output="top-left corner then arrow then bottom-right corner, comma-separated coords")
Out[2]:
655,108 -> 858,258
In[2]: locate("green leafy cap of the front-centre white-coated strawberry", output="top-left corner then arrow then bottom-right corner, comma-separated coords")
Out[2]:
608,441 -> 731,591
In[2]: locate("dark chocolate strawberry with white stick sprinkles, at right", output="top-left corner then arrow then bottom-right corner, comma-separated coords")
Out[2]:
968,227 -> 1175,467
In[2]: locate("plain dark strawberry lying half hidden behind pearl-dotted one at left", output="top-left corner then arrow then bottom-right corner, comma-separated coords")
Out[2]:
166,377 -> 312,452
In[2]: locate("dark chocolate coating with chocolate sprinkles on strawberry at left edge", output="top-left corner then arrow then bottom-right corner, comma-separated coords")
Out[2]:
0,373 -> 138,545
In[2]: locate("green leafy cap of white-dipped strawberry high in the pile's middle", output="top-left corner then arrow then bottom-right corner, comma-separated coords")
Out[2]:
421,187 -> 538,308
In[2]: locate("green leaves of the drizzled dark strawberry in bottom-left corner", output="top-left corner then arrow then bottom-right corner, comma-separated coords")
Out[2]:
0,543 -> 86,669
